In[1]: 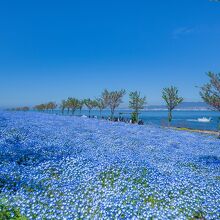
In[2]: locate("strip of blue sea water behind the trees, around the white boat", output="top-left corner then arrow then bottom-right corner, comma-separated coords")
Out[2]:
55,110 -> 220,131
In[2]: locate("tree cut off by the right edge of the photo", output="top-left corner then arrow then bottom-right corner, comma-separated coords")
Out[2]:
200,72 -> 220,133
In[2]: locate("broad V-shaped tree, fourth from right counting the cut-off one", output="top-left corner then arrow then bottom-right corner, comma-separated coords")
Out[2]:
103,89 -> 126,119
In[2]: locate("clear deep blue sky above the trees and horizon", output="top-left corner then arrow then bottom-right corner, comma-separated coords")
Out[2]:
0,0 -> 220,107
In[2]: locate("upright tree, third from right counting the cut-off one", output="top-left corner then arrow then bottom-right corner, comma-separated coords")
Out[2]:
129,91 -> 146,123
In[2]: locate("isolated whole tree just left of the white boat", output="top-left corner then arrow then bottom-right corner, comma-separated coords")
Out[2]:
162,86 -> 183,123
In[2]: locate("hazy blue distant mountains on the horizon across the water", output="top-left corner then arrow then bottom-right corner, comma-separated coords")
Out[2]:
145,102 -> 209,110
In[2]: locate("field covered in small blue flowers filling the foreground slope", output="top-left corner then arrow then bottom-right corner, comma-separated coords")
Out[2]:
0,112 -> 220,219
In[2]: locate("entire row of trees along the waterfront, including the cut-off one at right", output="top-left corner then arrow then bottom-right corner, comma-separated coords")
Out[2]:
11,72 -> 220,123
